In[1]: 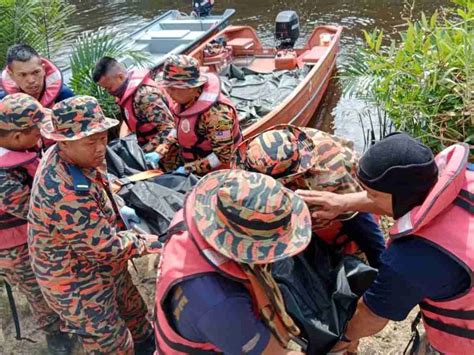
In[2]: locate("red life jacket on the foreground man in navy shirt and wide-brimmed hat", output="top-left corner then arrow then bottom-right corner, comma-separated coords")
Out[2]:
154,204 -> 300,355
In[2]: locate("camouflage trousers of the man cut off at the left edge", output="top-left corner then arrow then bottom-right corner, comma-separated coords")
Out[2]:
0,244 -> 59,328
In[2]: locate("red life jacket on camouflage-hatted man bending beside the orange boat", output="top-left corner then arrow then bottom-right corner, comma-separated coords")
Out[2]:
173,73 -> 242,169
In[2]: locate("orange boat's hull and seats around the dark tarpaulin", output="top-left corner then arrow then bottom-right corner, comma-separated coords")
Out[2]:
190,26 -> 342,138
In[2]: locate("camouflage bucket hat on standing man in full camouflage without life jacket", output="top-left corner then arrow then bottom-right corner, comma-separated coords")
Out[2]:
41,96 -> 119,141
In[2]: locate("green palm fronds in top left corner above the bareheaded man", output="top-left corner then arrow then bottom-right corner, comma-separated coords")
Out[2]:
0,0 -> 77,68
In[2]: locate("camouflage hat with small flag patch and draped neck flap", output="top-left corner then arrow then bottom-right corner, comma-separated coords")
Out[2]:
232,125 -> 362,229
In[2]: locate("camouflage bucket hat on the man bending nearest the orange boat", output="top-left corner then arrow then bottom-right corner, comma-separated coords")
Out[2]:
158,55 -> 207,89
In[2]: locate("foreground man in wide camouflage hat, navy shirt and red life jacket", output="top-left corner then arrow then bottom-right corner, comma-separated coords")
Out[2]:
154,170 -> 311,355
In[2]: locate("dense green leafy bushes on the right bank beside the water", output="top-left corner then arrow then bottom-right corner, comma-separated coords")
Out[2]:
341,0 -> 474,156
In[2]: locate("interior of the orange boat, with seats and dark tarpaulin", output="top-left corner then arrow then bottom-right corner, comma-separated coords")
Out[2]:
193,26 -> 338,128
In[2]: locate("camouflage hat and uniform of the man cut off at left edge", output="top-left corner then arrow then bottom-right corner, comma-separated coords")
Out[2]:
0,94 -> 59,328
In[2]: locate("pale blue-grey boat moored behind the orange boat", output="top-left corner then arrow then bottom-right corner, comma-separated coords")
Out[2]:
63,9 -> 235,82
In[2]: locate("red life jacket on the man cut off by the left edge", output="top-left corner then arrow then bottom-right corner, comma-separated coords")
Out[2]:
0,148 -> 39,250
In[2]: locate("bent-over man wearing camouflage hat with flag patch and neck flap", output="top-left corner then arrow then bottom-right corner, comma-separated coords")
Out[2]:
232,125 -> 385,268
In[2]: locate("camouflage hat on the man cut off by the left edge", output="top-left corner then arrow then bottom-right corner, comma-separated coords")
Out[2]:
0,93 -> 50,131
